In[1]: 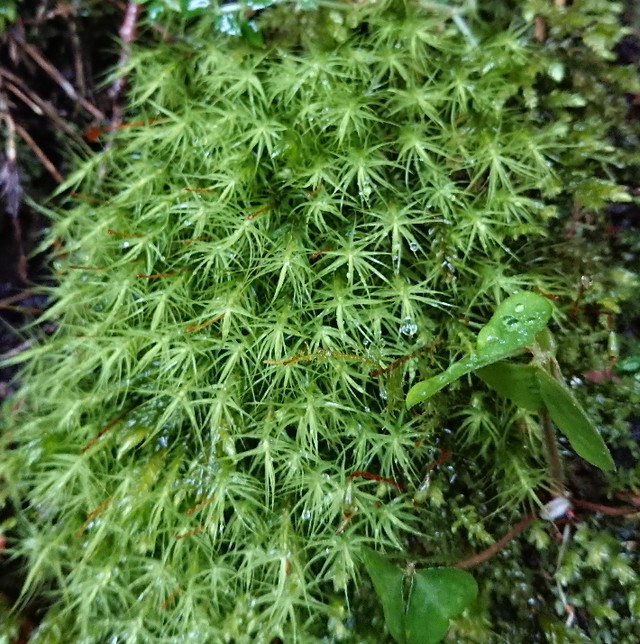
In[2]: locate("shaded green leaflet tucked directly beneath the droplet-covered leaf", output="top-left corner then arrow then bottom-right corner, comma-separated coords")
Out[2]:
476,361 -> 544,411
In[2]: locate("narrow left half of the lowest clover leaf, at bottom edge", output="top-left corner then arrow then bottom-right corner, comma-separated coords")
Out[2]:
364,550 -> 408,644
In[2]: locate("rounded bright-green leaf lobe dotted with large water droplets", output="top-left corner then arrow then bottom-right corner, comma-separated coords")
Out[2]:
477,293 -> 553,362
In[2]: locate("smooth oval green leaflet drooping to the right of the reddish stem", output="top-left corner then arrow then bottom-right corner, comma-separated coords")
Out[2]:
536,369 -> 615,471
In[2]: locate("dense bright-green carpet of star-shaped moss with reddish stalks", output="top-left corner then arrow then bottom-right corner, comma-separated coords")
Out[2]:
1,1 -> 638,644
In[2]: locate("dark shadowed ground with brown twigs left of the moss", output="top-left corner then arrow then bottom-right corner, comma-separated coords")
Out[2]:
0,0 -> 122,400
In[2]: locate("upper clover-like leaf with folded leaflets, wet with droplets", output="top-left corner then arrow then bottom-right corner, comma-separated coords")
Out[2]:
407,292 -> 614,471
